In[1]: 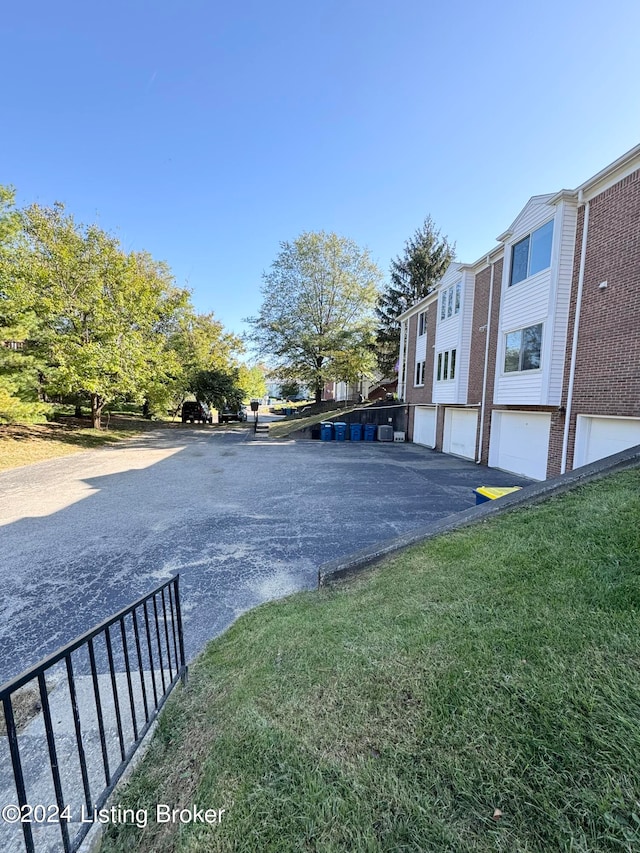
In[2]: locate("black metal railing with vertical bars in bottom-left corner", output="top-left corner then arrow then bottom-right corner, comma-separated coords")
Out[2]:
0,575 -> 187,853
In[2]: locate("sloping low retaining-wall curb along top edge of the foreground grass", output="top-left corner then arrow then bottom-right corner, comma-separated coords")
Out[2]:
318,444 -> 640,588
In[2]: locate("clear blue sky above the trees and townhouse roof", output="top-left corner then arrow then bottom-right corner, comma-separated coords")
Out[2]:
0,0 -> 640,332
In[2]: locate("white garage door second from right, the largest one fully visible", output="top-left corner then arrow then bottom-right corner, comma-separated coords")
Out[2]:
489,411 -> 551,480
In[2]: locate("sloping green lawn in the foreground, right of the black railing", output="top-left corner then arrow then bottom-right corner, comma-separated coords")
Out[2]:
102,471 -> 640,853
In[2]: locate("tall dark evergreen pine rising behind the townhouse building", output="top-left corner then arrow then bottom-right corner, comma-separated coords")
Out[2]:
376,216 -> 455,376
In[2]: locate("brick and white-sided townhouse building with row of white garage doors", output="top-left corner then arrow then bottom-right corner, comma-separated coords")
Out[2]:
398,146 -> 640,480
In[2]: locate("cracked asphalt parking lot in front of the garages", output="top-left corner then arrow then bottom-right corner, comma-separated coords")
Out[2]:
0,426 -> 528,683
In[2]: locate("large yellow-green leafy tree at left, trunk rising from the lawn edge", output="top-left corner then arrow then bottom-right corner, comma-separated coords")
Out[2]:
14,204 -> 188,429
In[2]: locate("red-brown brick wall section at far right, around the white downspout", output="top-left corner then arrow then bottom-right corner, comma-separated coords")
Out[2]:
549,170 -> 640,473
